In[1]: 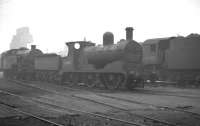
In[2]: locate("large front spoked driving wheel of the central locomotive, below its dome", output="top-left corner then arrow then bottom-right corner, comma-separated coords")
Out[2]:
101,73 -> 124,90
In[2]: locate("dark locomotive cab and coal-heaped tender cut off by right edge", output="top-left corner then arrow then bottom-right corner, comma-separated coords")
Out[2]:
142,34 -> 200,85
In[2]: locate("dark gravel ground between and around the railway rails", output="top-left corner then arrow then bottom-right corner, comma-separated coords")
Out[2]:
0,80 -> 200,126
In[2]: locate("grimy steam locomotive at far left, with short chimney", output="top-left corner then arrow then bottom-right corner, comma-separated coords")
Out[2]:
1,45 -> 43,79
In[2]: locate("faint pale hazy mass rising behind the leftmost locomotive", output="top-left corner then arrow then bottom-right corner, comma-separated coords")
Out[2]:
10,27 -> 33,49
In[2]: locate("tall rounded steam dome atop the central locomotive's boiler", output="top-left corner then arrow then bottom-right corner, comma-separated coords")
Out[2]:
103,32 -> 114,46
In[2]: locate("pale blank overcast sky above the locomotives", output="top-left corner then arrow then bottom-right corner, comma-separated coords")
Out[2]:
0,0 -> 200,52
